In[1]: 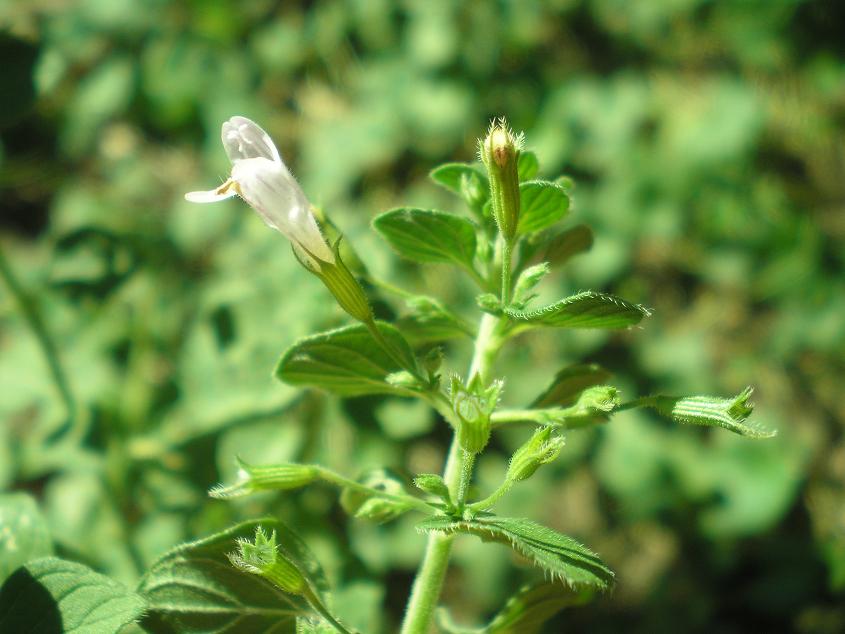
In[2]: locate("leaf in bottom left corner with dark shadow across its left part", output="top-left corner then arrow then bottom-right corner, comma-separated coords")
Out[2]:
0,557 -> 144,634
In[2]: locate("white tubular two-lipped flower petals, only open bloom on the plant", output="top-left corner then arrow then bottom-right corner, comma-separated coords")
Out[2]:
185,117 -> 335,270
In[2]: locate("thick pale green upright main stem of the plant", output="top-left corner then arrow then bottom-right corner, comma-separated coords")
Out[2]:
401,314 -> 501,634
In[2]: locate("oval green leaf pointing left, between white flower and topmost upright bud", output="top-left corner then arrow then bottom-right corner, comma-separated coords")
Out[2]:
373,207 -> 476,269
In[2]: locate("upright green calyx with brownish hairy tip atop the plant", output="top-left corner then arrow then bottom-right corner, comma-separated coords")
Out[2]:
478,118 -> 523,243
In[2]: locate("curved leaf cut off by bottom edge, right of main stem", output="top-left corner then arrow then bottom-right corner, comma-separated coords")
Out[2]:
437,582 -> 594,634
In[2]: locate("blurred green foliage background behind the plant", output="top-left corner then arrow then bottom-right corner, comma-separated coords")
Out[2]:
0,0 -> 845,633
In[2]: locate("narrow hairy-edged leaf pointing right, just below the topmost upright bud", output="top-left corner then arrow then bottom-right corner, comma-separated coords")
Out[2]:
504,291 -> 651,329
